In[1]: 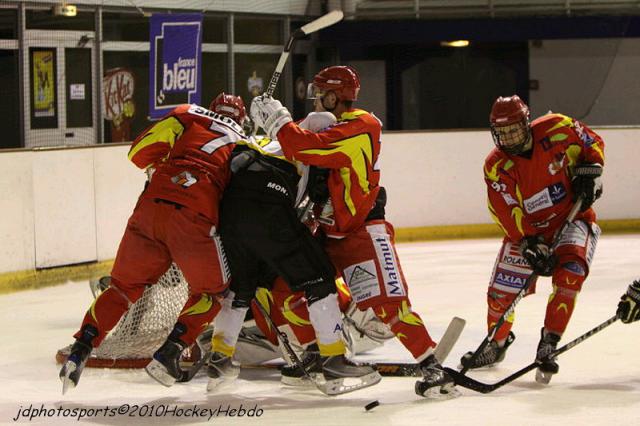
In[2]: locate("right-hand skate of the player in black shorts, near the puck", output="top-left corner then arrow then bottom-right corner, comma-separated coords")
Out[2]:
320,355 -> 382,395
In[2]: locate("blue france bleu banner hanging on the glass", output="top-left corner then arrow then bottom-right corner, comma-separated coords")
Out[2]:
149,13 -> 202,120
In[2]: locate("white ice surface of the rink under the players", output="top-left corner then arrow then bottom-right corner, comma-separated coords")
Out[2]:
0,235 -> 640,426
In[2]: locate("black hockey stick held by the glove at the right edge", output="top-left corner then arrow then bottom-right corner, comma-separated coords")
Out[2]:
445,314 -> 618,393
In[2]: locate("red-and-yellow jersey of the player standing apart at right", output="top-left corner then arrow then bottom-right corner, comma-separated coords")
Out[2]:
484,114 -> 604,241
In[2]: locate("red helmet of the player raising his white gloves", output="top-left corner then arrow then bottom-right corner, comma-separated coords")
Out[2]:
307,65 -> 360,101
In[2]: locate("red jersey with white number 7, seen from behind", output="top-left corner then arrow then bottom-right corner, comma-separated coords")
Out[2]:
129,105 -> 245,223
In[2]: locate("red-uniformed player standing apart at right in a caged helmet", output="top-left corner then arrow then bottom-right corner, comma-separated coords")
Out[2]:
461,95 -> 604,383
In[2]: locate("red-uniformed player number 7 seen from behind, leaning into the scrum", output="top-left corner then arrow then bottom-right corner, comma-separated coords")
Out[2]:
60,93 -> 246,393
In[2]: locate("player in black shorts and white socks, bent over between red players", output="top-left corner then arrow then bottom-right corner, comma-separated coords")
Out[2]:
207,110 -> 380,393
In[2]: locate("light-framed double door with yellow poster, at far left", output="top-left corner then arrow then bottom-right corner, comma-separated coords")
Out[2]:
24,30 -> 97,148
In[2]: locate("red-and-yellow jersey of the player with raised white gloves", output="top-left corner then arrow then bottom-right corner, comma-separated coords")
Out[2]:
278,109 -> 382,238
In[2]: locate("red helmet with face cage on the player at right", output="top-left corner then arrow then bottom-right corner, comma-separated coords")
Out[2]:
489,95 -> 532,154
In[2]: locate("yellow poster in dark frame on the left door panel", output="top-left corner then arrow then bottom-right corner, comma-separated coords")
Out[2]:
29,47 -> 58,129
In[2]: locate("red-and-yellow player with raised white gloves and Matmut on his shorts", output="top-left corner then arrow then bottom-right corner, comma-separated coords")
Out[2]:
250,66 -> 454,396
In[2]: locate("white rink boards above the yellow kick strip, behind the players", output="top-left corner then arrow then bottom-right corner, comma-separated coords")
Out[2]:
0,128 -> 640,273
